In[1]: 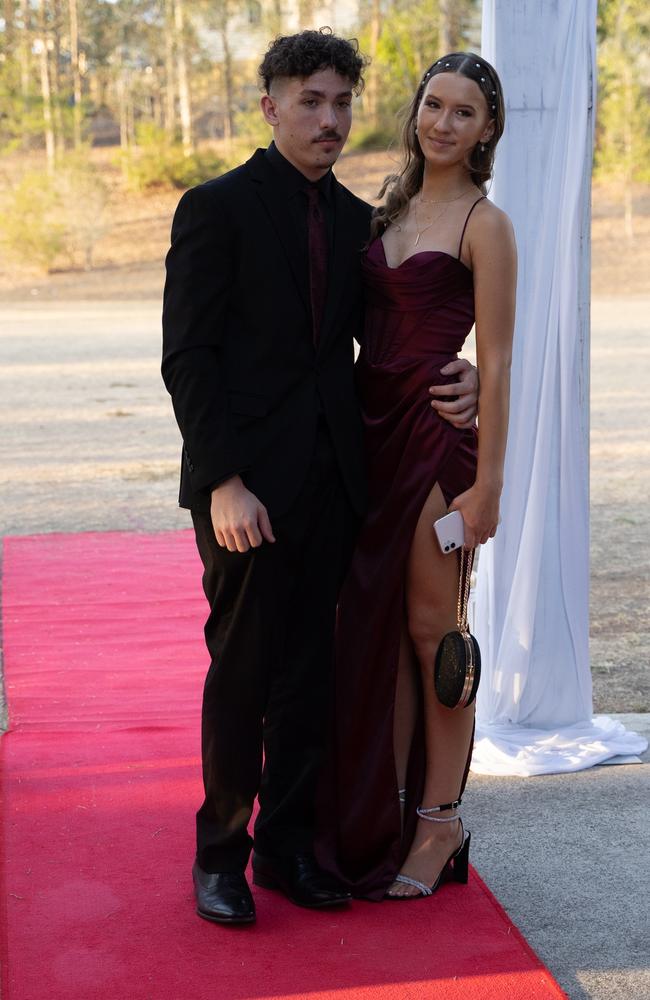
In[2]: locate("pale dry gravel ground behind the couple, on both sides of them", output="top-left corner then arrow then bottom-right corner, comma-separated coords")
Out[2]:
0,297 -> 650,712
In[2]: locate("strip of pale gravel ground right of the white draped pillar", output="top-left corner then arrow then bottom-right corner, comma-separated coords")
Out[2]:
591,299 -> 650,712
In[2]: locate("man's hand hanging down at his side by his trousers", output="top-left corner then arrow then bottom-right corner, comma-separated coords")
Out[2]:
210,476 -> 275,552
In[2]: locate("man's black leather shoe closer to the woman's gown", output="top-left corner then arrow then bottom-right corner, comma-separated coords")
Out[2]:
253,851 -> 352,909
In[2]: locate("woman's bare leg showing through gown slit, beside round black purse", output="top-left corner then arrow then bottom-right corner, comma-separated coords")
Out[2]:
390,485 -> 474,896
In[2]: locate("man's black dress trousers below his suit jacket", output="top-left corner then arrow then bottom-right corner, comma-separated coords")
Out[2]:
192,427 -> 358,872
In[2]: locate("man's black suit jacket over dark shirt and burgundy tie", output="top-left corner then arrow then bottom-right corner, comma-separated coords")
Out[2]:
162,150 -> 371,515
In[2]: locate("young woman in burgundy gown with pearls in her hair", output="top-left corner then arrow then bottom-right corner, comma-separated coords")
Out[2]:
320,52 -> 516,899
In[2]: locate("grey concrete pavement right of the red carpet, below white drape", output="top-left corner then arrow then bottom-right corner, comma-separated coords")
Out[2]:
463,714 -> 650,1000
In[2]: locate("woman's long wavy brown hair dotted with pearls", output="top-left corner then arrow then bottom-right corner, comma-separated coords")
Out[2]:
370,52 -> 506,242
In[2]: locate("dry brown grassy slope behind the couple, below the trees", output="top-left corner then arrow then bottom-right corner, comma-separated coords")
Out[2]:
0,149 -> 650,302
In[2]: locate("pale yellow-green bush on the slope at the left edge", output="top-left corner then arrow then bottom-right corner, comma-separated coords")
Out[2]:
0,153 -> 107,271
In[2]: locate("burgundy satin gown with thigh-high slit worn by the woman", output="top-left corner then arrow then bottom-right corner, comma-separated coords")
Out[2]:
319,199 -> 480,899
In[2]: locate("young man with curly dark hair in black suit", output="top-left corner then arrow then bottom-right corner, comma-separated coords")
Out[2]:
162,31 -> 476,923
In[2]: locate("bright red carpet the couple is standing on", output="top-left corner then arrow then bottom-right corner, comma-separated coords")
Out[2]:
1,532 -> 565,1000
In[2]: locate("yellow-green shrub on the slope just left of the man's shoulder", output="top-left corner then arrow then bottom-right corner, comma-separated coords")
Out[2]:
118,122 -> 226,191
